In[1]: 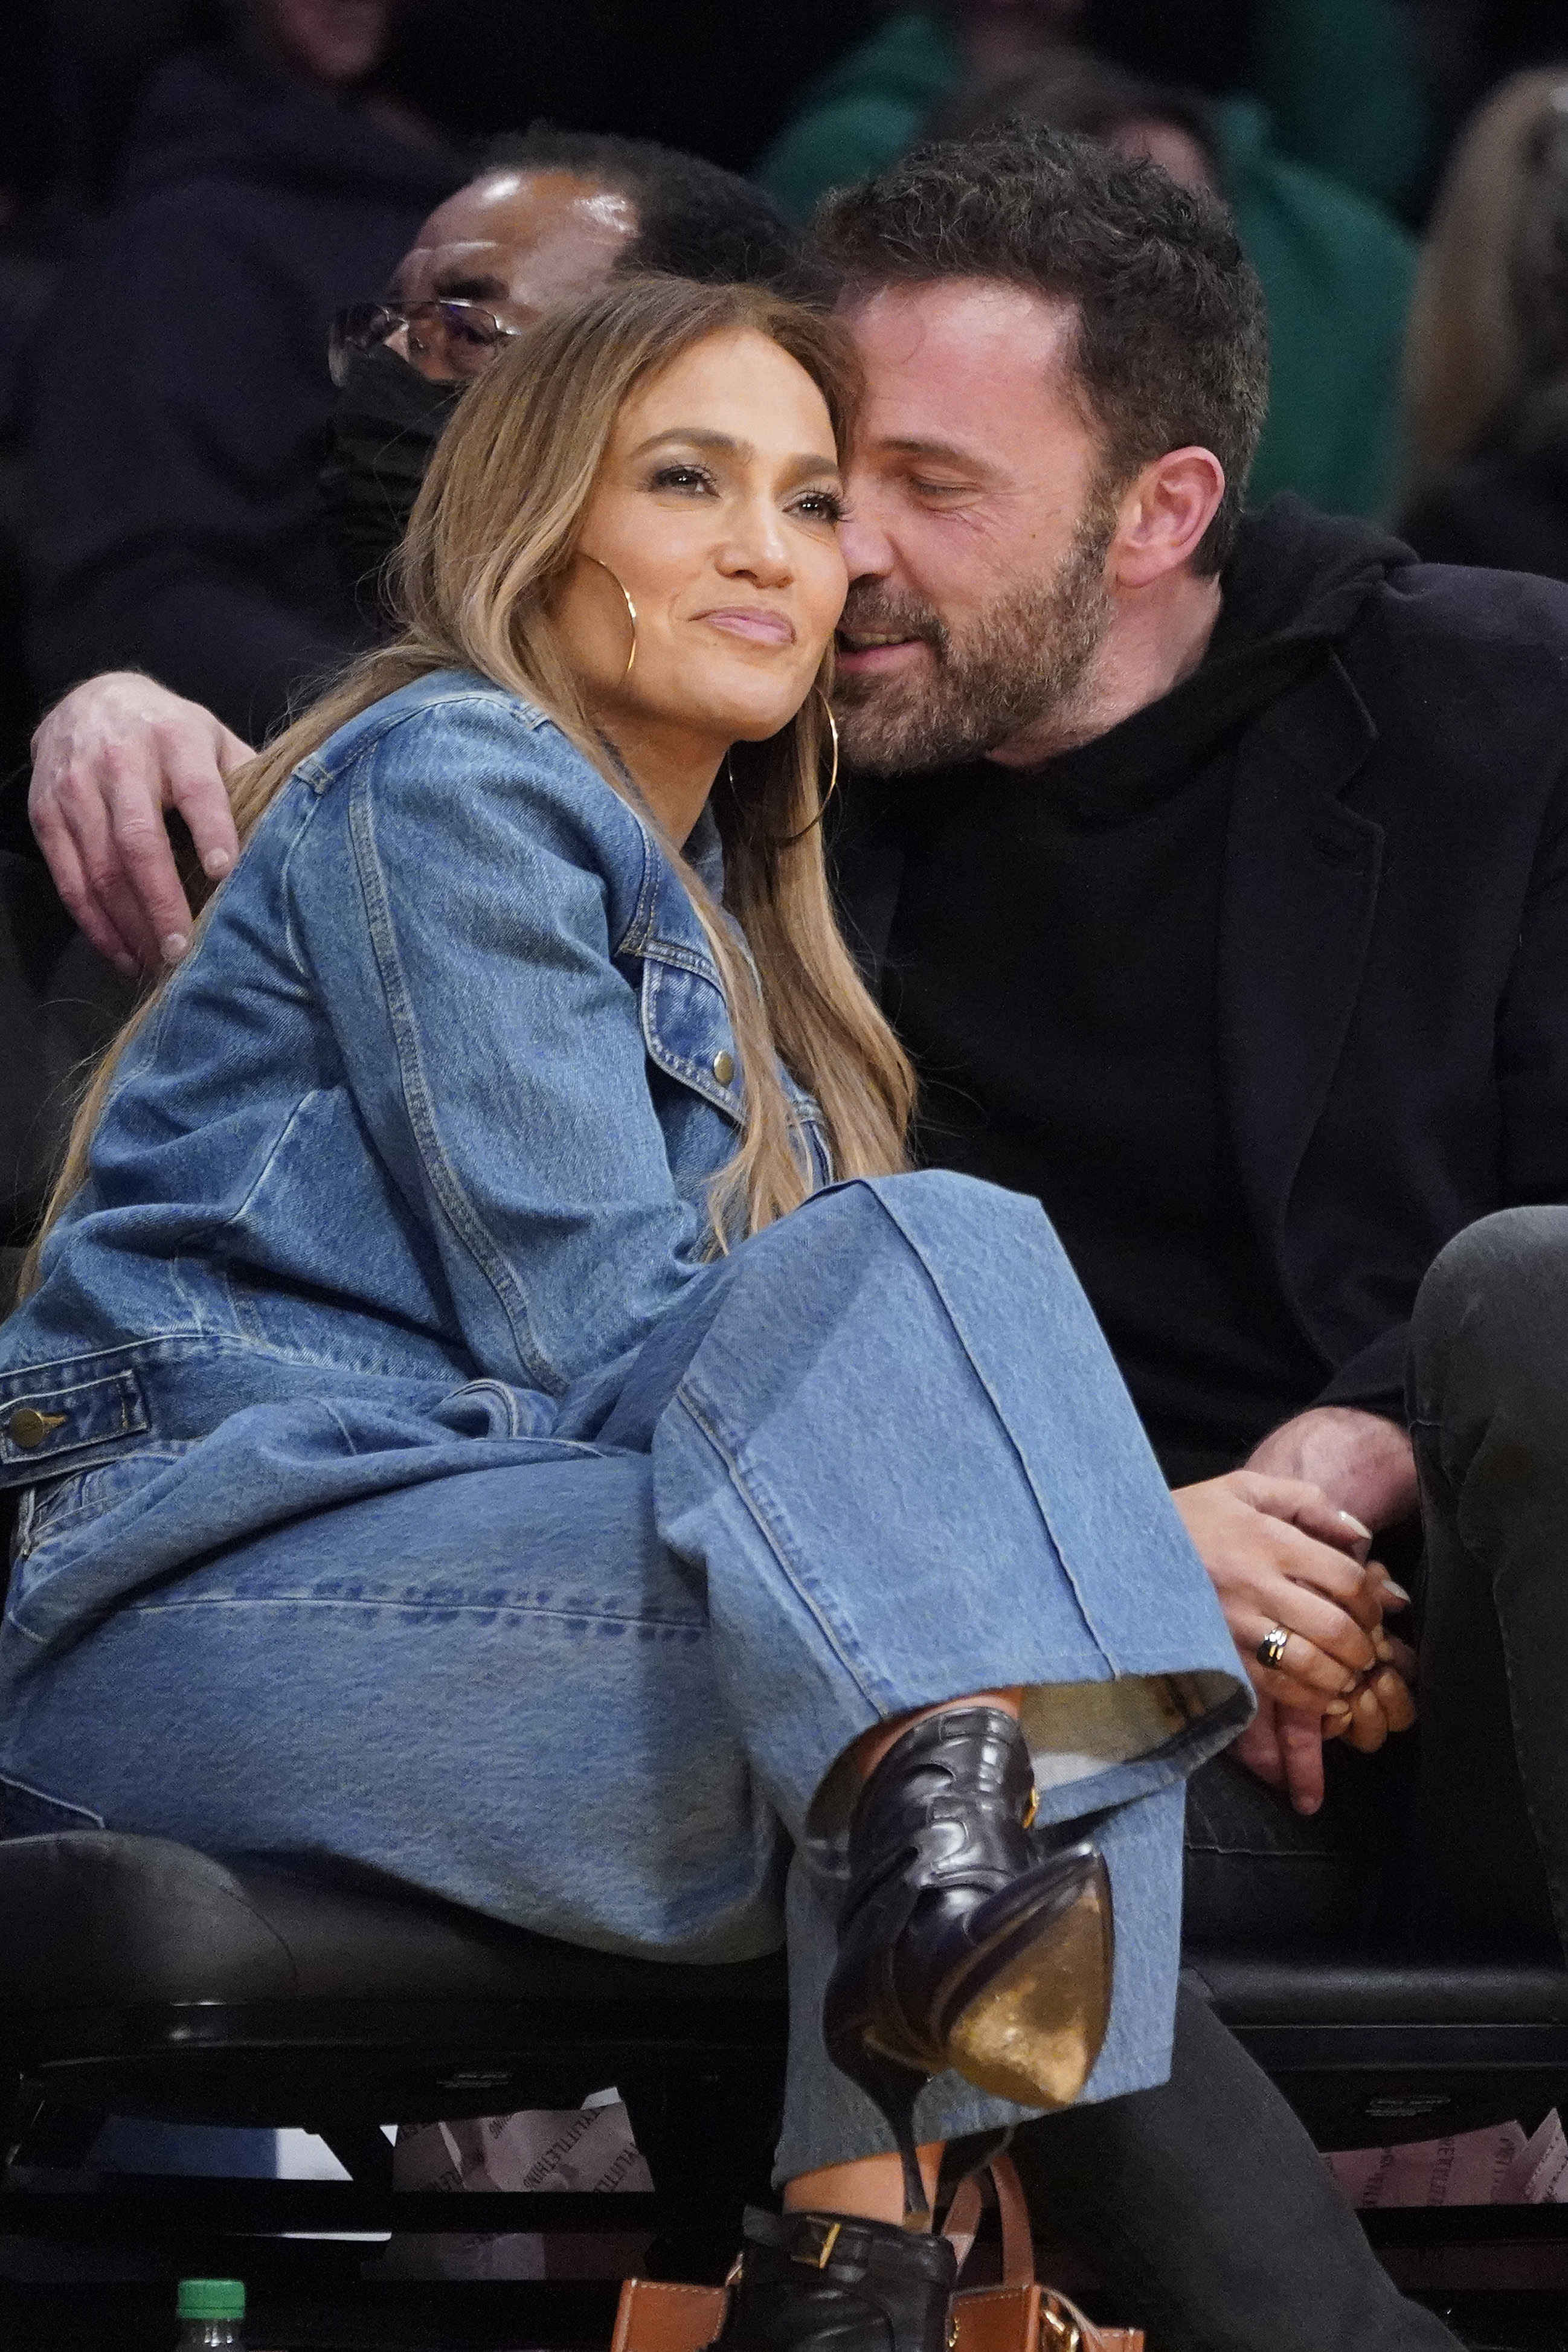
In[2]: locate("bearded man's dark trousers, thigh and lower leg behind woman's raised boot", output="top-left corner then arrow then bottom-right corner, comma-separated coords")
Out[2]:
992,1505 -> 1457,2352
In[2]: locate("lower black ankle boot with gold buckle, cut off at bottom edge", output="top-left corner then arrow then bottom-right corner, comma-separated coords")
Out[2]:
715,2206 -> 959,2352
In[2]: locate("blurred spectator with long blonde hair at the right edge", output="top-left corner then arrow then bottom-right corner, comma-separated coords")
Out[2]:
1401,66 -> 1568,581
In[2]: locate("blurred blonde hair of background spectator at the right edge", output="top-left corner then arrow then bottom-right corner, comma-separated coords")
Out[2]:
1406,66 -> 1568,492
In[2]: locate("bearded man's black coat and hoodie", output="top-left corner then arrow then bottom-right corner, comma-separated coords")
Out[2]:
839,499 -> 1568,1484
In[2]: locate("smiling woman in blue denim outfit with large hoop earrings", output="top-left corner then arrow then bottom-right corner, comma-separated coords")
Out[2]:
0,280 -> 1250,2352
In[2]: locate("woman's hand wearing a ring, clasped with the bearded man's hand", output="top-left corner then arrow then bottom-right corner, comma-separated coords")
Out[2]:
1173,1470 -> 1387,1731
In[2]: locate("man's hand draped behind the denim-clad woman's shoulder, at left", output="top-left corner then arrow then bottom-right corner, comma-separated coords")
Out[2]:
28,670 -> 251,974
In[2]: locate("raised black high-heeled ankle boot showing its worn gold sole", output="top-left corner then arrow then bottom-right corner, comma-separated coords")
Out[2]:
823,1708 -> 1112,2218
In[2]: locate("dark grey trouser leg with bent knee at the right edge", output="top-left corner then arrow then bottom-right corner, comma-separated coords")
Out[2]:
1410,1209 -> 1568,1959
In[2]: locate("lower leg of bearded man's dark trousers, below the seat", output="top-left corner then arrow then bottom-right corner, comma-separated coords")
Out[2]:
1013,1990 -> 1457,2352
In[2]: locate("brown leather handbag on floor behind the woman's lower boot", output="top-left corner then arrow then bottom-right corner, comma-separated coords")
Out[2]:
611,2157 -> 1143,2352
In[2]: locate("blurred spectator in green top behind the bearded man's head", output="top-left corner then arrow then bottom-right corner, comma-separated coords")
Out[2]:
754,0 -> 1415,515
